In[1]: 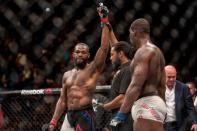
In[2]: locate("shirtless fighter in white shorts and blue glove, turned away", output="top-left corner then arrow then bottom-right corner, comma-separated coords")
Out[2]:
110,18 -> 166,131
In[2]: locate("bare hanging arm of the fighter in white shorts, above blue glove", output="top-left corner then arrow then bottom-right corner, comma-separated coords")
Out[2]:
120,50 -> 151,113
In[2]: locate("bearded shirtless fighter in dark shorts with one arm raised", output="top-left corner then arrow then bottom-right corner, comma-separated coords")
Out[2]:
49,26 -> 109,131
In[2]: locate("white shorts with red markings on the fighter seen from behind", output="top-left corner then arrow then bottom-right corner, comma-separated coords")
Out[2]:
131,96 -> 167,123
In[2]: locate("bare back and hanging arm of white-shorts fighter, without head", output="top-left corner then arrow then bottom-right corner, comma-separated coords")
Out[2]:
121,25 -> 165,113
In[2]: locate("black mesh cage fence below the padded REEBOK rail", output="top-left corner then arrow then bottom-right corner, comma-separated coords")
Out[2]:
0,86 -> 110,131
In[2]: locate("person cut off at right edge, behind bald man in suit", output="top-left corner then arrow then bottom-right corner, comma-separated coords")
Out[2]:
186,82 -> 197,110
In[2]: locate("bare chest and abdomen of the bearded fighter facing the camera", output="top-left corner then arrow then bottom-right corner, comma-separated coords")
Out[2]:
63,63 -> 100,110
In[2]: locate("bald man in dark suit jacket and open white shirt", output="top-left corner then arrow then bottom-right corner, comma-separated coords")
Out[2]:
164,65 -> 197,131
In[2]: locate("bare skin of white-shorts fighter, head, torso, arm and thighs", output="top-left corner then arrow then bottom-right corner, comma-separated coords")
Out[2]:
120,18 -> 165,131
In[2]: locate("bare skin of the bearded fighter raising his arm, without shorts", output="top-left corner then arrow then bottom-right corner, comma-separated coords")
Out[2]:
50,27 -> 109,131
